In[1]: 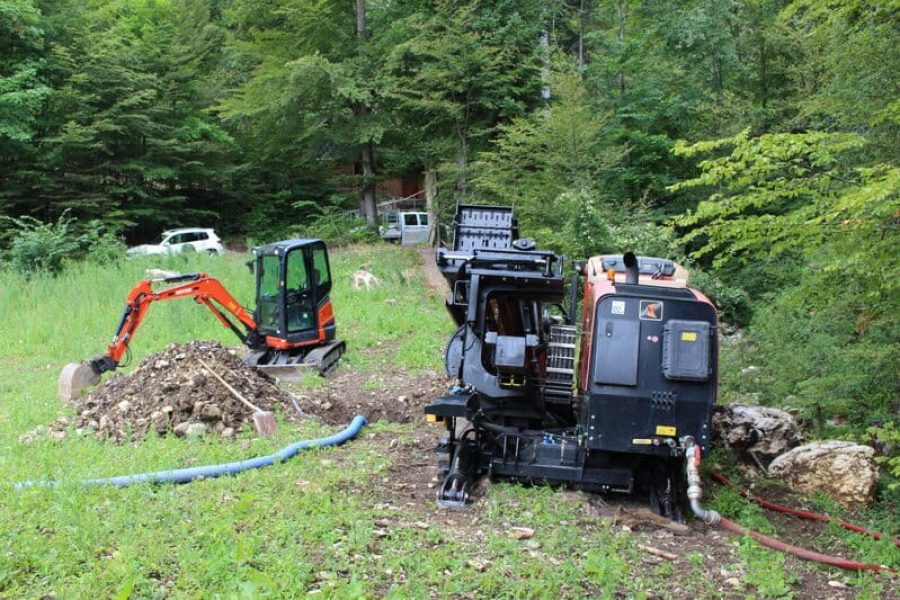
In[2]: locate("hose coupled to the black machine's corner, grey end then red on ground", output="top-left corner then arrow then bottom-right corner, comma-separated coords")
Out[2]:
684,437 -> 897,574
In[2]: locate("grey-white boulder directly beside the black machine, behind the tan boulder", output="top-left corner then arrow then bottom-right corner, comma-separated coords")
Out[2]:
712,404 -> 803,461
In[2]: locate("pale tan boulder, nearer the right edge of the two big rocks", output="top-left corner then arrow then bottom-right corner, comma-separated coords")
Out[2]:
769,440 -> 878,507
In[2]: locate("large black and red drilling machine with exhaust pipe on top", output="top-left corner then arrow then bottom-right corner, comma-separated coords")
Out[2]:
425,205 -> 718,517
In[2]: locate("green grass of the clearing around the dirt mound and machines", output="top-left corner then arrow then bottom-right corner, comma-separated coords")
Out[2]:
0,246 -> 890,598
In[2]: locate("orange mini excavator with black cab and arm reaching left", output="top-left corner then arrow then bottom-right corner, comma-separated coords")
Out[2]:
59,239 -> 346,400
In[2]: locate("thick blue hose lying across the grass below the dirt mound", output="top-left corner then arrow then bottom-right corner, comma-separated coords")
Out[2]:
14,415 -> 366,490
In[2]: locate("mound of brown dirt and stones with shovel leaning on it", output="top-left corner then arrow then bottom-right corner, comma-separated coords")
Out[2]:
66,341 -> 296,442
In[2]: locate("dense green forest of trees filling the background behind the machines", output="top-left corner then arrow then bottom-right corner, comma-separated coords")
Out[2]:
0,0 -> 900,436
